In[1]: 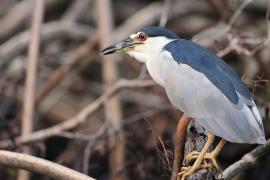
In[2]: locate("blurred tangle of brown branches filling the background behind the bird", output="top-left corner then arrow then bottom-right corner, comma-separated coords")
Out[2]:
0,0 -> 270,180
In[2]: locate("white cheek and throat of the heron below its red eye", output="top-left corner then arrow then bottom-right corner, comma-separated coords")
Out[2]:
127,36 -> 174,63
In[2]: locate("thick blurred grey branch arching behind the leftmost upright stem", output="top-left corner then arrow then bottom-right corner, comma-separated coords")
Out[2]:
0,21 -> 93,73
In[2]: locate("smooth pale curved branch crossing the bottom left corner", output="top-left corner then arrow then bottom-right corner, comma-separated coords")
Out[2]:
0,150 -> 94,180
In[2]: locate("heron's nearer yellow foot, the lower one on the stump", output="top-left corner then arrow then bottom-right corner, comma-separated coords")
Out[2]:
177,163 -> 213,180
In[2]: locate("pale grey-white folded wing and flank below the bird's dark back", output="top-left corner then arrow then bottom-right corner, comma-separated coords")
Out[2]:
159,48 -> 265,144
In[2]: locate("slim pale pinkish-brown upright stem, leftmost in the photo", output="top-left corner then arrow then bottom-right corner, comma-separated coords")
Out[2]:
18,0 -> 44,180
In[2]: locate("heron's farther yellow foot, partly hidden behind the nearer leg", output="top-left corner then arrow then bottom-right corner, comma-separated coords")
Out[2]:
184,151 -> 221,173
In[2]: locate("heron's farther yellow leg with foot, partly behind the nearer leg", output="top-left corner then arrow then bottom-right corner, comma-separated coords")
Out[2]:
185,139 -> 226,171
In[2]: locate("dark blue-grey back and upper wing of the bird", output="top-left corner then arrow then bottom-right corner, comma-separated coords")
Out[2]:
164,39 -> 254,106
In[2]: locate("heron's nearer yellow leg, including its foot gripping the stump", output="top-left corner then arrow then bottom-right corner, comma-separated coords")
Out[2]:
178,133 -> 215,180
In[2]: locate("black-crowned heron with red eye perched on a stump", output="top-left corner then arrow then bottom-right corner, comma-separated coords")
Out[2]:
101,26 -> 266,180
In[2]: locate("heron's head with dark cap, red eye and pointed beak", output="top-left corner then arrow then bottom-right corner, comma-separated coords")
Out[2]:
101,27 -> 178,63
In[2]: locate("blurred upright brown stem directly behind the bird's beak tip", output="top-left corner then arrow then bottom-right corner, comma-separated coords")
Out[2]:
95,0 -> 127,180
